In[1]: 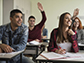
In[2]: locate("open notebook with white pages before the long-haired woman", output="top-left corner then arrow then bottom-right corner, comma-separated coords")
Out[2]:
40,52 -> 84,60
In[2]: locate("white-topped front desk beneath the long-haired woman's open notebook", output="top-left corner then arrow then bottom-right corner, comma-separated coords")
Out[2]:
36,51 -> 84,63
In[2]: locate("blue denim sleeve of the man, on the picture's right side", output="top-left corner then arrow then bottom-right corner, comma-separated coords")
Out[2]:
11,27 -> 28,51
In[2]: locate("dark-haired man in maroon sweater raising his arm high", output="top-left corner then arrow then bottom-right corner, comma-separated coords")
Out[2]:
28,2 -> 46,42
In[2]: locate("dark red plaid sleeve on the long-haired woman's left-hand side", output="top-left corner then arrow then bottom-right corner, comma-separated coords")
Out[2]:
48,30 -> 58,52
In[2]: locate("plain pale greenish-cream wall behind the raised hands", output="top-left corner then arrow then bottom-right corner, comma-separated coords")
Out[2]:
31,0 -> 84,36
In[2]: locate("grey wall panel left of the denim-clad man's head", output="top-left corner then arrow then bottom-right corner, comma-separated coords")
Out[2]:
3,0 -> 14,24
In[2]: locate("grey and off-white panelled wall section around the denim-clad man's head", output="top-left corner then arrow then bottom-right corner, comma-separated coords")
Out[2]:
3,0 -> 31,25
